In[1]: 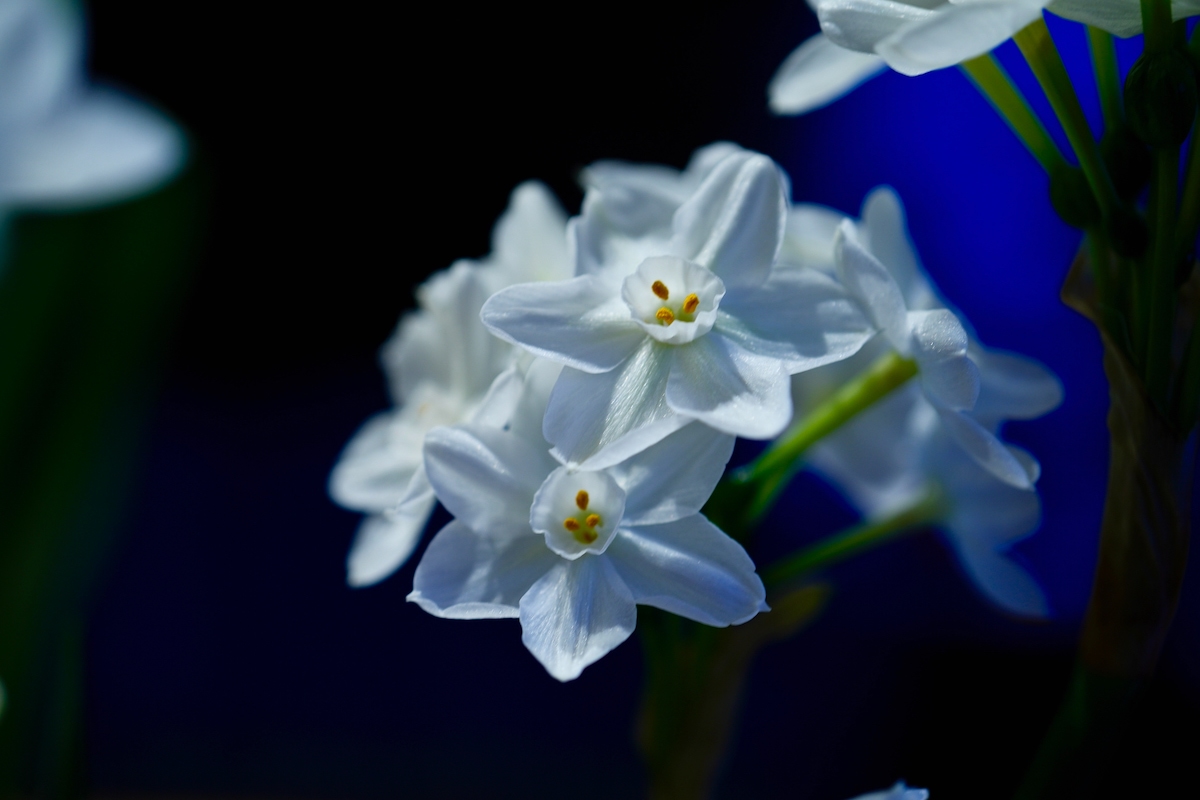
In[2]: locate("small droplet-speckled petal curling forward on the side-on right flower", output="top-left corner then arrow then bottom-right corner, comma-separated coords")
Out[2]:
908,308 -> 979,411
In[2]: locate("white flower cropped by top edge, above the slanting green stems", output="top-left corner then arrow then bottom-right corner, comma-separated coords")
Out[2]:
767,0 -> 1051,114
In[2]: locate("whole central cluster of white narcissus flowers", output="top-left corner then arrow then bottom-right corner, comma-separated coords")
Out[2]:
330,143 -> 1060,680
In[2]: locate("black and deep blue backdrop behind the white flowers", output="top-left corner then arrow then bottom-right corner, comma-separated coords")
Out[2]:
56,0 -> 1200,800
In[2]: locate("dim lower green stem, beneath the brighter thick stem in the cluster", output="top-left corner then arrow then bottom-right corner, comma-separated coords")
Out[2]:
760,489 -> 946,590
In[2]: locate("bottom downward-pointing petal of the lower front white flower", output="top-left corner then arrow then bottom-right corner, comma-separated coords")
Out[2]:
521,557 -> 637,681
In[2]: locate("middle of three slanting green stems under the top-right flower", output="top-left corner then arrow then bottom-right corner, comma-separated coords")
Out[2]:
1013,18 -> 1121,219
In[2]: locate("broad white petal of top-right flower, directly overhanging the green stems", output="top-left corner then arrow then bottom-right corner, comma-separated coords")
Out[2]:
875,0 -> 1048,76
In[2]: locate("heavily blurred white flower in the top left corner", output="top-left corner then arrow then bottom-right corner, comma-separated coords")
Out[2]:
0,0 -> 185,212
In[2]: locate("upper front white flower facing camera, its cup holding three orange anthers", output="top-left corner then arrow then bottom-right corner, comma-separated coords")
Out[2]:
482,149 -> 874,467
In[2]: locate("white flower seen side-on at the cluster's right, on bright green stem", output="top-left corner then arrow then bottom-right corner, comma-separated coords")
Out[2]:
792,187 -> 1062,489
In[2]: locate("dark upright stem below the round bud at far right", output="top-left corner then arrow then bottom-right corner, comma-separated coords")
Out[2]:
1146,148 -> 1180,403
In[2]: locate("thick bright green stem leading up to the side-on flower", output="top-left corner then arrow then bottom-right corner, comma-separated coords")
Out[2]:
734,350 -> 917,527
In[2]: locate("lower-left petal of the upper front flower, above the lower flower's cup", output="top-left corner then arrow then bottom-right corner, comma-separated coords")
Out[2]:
542,337 -> 686,469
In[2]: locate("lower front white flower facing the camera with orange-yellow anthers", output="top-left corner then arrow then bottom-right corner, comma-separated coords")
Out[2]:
408,360 -> 766,681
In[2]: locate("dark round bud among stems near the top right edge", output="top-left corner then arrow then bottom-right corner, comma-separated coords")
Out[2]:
1124,49 -> 1196,148
